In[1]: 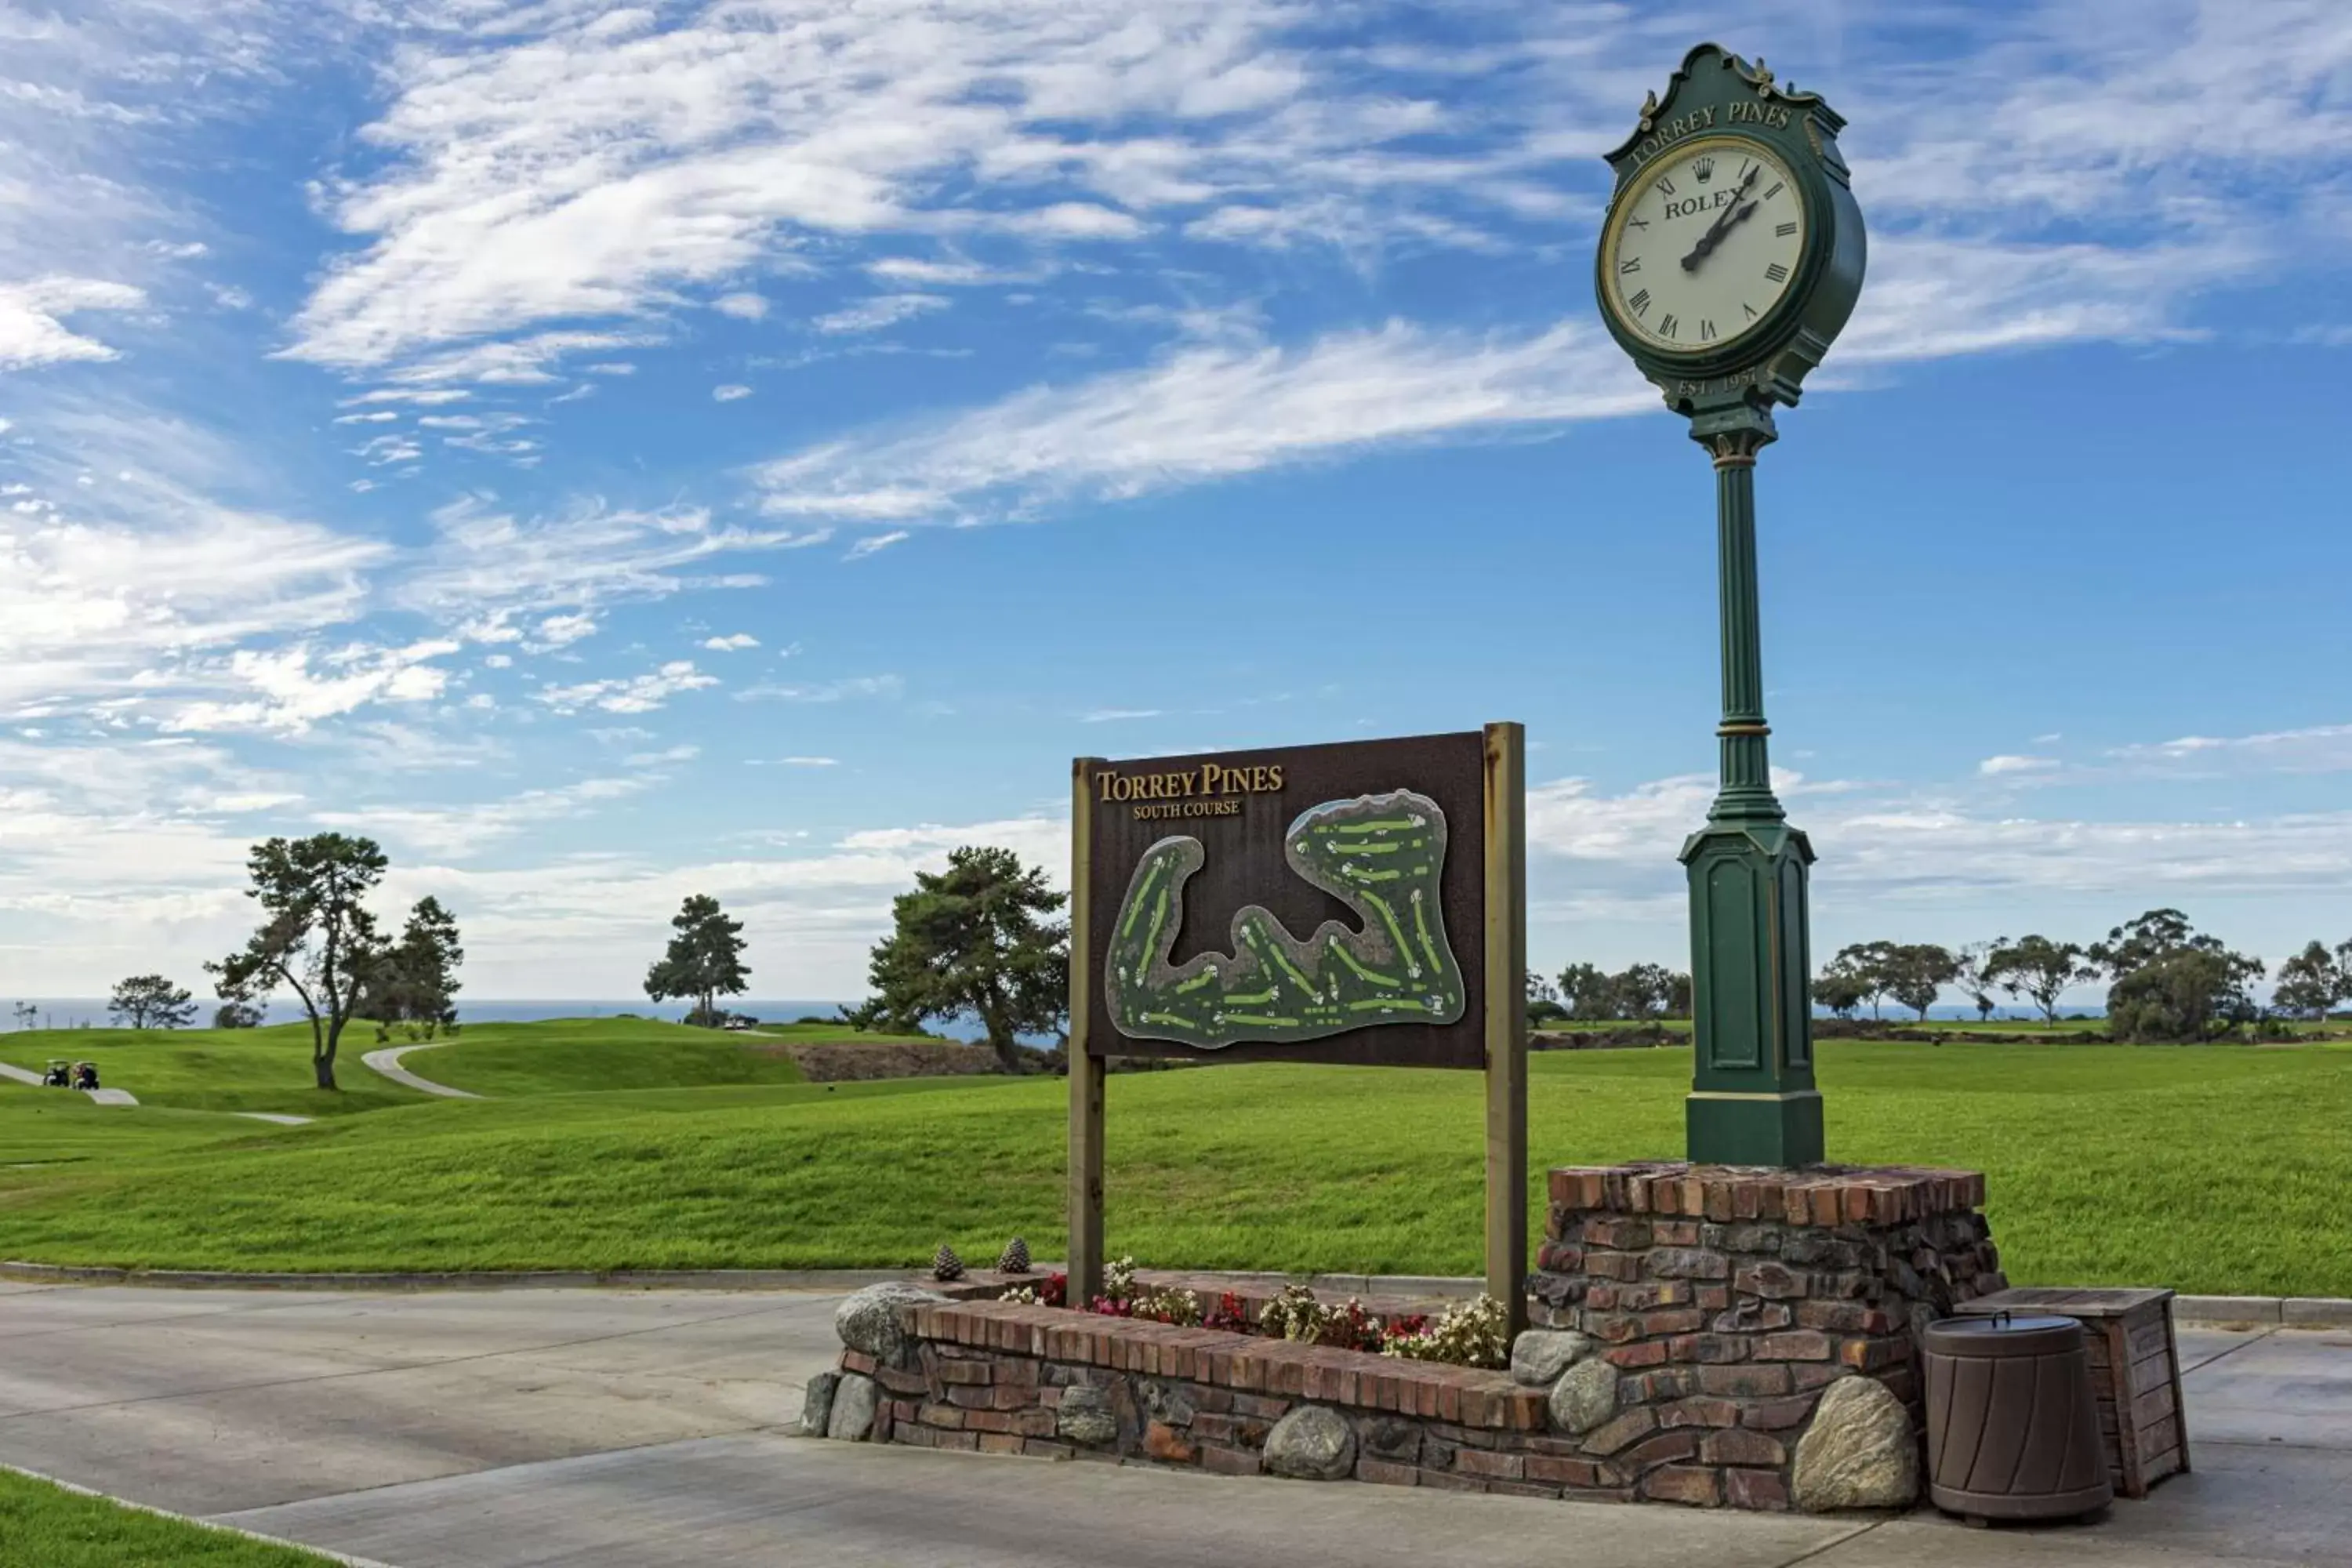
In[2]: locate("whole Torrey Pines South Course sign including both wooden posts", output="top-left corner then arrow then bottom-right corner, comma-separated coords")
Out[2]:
1068,724 -> 1526,1333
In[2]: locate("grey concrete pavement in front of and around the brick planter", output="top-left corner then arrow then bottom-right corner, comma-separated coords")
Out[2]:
0,1283 -> 2352,1568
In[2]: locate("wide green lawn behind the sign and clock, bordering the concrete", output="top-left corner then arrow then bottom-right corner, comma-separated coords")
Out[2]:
0,1041 -> 2352,1295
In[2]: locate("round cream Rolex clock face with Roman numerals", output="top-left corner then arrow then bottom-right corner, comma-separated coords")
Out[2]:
1602,136 -> 1806,353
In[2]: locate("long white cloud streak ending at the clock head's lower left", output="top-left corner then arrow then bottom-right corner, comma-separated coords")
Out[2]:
755,322 -> 1658,522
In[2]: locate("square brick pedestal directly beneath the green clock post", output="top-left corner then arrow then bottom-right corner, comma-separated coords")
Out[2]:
1529,1161 -> 2009,1509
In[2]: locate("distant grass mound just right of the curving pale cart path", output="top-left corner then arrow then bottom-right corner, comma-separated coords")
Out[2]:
402,1018 -> 946,1095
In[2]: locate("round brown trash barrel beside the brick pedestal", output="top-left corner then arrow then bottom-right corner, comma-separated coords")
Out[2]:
1922,1312 -> 2114,1519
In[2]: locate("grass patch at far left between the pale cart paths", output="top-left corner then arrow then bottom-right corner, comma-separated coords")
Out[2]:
0,1022 -> 426,1116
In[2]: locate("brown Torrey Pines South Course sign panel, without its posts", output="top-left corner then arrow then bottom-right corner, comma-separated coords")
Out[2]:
1080,731 -> 1486,1067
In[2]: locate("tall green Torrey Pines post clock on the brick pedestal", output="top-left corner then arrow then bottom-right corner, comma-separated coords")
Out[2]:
1595,45 -> 1863,1166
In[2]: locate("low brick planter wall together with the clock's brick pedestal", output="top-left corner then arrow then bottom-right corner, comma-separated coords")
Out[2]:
828,1163 -> 2006,1509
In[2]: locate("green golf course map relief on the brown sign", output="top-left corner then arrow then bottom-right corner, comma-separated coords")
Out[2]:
1108,789 -> 1468,1048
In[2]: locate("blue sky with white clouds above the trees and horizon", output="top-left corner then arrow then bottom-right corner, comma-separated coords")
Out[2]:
0,0 -> 2352,996
